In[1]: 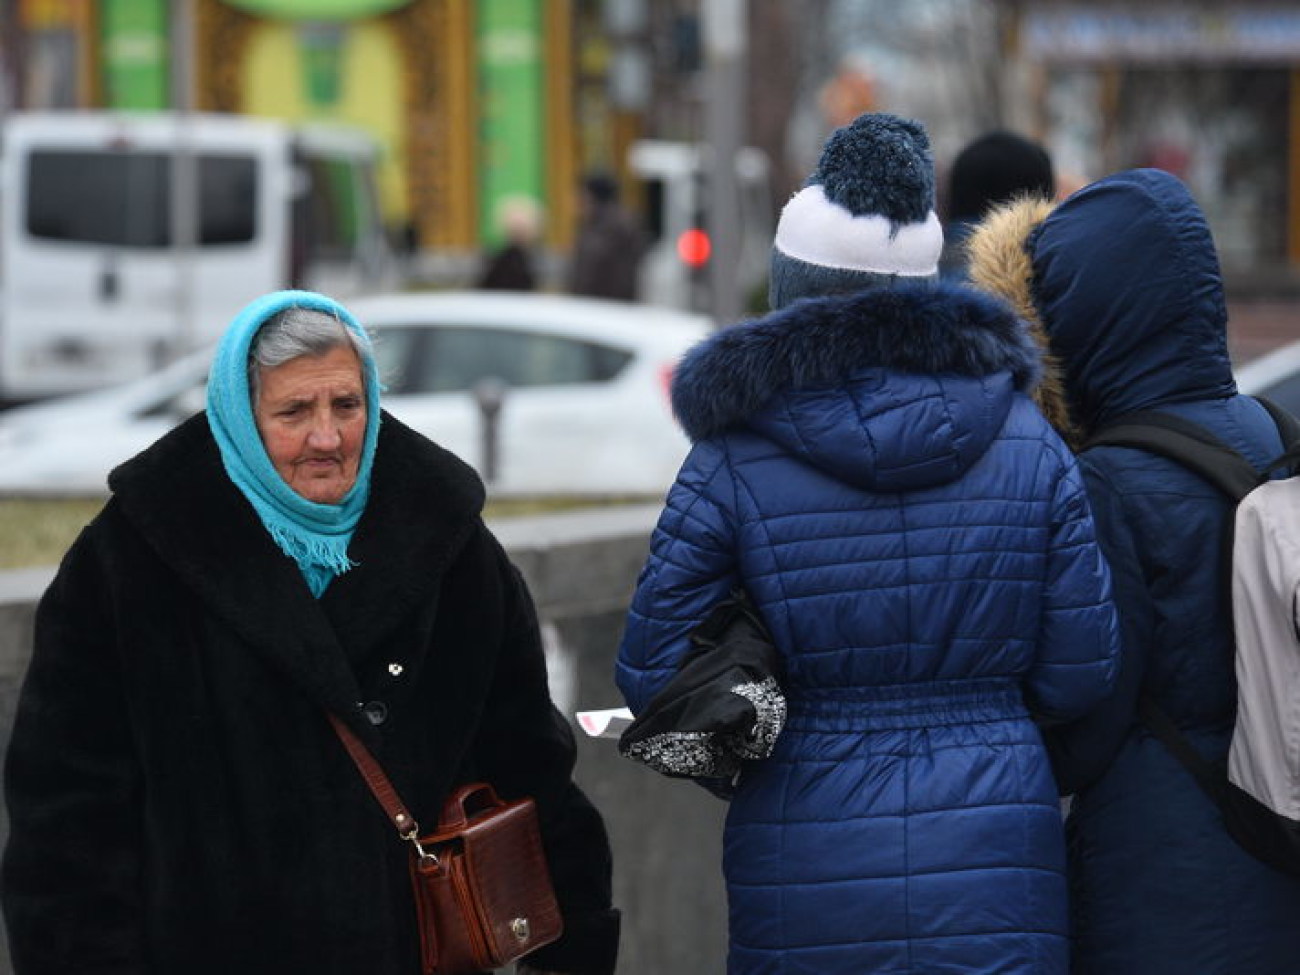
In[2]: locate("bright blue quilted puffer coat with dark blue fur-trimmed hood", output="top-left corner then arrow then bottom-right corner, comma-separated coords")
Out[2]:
616,287 -> 1118,975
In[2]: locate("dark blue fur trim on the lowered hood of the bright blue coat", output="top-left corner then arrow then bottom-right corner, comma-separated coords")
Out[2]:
672,285 -> 1040,441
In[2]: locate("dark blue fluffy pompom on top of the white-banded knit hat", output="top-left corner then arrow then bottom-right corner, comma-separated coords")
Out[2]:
809,113 -> 935,224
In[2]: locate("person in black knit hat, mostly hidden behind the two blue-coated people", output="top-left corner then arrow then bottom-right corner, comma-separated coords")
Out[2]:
939,129 -> 1056,281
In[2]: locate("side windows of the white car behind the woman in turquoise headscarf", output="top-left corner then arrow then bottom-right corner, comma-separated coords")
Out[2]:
384,325 -> 632,393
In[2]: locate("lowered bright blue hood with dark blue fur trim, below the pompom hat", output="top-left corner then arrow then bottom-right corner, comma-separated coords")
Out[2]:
672,286 -> 1040,490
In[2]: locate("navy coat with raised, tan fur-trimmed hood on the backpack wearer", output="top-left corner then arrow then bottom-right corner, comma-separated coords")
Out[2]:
970,169 -> 1300,975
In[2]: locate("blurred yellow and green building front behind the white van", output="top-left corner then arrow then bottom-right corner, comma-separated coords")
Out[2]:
0,0 -> 660,275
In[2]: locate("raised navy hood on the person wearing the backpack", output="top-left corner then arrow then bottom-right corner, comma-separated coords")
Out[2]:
971,169 -> 1236,439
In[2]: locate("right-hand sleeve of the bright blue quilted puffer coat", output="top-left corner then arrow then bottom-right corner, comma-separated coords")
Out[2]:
1028,458 -> 1119,723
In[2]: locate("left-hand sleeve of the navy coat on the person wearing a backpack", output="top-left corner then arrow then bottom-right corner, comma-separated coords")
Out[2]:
1044,459 -> 1154,796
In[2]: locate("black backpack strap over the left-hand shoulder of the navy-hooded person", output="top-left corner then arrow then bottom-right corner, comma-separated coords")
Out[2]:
1082,410 -> 1258,501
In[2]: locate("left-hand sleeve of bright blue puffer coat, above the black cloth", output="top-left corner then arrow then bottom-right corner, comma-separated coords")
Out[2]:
615,441 -> 738,714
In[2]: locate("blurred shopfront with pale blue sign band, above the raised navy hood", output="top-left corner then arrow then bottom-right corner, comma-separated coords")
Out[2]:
998,0 -> 1300,296
